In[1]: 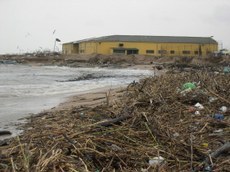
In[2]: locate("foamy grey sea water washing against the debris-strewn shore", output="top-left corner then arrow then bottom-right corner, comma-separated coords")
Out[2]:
0,64 -> 153,139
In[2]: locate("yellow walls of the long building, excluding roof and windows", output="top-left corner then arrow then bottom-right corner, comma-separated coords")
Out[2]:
63,41 -> 218,56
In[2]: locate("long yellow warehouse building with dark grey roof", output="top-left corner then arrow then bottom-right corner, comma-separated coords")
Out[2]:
62,35 -> 218,57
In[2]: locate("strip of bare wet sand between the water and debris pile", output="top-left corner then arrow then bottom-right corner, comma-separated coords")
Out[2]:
0,86 -> 126,141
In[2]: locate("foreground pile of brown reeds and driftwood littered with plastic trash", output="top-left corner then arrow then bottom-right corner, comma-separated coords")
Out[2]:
0,72 -> 230,172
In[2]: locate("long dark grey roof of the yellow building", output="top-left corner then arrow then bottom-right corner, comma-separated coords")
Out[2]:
65,35 -> 217,44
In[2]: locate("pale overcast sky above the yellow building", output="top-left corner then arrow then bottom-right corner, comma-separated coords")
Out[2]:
0,0 -> 230,54
